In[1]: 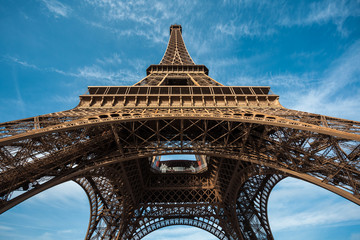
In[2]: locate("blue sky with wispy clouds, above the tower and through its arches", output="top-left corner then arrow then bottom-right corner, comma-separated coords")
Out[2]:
0,0 -> 360,240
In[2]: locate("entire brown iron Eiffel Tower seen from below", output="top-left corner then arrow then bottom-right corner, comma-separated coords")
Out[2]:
0,25 -> 360,239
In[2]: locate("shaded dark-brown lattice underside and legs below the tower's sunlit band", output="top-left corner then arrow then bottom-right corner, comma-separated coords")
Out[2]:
0,115 -> 360,239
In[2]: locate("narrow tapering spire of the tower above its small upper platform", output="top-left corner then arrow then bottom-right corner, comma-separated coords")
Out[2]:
160,25 -> 195,65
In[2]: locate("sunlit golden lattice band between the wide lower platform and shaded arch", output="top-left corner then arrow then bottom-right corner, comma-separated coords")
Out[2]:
0,106 -> 360,139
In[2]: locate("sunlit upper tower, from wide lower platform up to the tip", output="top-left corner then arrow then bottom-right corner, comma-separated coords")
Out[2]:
78,25 -> 281,108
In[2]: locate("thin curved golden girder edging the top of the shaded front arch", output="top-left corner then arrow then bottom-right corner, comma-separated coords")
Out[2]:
0,109 -> 360,146
